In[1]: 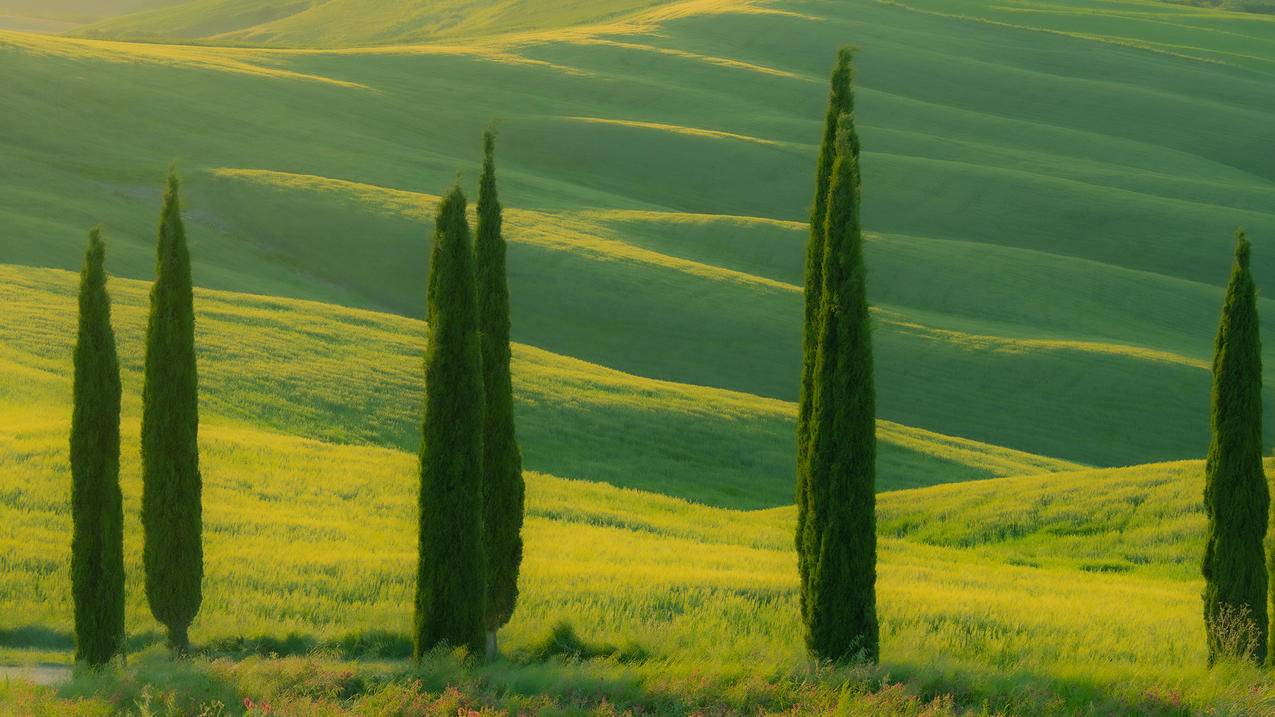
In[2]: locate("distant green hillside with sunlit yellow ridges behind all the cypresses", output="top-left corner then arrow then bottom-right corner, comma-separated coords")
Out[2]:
0,0 -> 1275,466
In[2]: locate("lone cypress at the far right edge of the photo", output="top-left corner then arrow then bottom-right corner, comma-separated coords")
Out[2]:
1204,232 -> 1270,663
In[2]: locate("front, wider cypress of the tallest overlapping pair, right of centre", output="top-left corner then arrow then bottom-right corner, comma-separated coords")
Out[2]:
803,115 -> 878,661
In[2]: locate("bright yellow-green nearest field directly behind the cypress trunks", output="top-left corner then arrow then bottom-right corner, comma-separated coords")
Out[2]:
0,390 -> 1275,714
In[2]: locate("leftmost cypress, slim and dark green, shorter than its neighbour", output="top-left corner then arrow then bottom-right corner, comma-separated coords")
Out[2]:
70,228 -> 124,667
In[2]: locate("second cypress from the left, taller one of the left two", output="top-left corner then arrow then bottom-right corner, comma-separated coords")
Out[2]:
142,171 -> 204,653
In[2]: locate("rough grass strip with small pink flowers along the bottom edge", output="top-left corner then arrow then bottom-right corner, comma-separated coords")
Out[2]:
0,649 -> 1275,717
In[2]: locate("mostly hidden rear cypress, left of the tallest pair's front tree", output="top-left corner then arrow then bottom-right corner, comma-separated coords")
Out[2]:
796,47 -> 859,617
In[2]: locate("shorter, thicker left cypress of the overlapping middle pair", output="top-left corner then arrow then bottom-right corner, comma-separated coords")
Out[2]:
413,182 -> 487,658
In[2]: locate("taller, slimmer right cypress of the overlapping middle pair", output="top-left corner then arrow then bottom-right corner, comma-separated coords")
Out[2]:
474,130 -> 525,654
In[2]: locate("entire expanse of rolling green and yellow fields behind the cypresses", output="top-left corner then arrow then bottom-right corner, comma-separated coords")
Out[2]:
0,0 -> 1275,714
